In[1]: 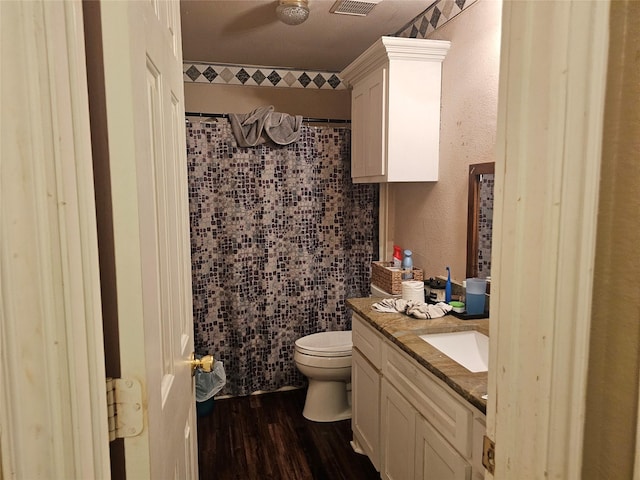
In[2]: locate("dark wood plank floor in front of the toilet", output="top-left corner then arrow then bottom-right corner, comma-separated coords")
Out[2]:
198,390 -> 380,480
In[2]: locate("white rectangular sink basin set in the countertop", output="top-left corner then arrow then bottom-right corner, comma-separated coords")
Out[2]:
420,330 -> 489,373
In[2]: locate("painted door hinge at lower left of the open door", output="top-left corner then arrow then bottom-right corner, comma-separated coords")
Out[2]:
107,377 -> 143,442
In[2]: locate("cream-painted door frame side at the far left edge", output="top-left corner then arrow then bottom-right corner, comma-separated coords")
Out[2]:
0,0 -> 110,479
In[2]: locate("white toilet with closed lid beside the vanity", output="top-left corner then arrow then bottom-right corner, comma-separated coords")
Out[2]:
293,330 -> 353,422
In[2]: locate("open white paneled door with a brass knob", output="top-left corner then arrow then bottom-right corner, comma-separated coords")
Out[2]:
92,0 -> 197,479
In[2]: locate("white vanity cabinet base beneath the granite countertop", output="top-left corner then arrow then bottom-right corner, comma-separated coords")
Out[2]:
352,313 -> 485,480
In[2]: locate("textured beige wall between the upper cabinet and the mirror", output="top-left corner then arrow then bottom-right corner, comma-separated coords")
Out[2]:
387,0 -> 502,280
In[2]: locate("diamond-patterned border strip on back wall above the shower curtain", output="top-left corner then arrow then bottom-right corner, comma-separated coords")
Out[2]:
183,63 -> 346,90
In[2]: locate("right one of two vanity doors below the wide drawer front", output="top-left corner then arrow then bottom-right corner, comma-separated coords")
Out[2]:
416,416 -> 471,480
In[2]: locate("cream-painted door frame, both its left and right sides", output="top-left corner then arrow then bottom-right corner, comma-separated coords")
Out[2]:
0,0 -> 624,478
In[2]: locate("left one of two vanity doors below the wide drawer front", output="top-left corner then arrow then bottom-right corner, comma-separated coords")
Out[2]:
381,379 -> 419,480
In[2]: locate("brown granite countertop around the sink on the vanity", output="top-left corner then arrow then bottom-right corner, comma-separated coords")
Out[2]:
347,297 -> 489,414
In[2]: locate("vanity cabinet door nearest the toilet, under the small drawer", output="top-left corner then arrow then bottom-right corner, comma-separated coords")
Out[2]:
351,349 -> 380,471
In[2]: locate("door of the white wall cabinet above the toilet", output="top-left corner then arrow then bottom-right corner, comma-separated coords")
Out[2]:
351,67 -> 387,178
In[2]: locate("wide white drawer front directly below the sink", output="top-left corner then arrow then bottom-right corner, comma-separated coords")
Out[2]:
382,344 -> 473,459
